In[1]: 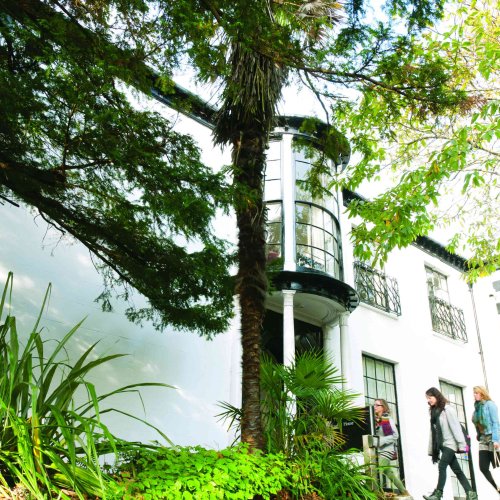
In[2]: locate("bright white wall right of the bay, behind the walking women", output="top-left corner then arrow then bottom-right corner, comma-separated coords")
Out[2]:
342,206 -> 500,500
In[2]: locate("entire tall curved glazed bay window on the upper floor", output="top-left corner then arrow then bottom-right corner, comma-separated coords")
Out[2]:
264,133 -> 343,280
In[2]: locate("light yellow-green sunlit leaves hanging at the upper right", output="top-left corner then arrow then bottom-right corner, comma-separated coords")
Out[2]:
334,0 -> 500,282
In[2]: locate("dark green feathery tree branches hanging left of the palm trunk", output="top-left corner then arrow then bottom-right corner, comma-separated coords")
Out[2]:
0,0 -> 232,336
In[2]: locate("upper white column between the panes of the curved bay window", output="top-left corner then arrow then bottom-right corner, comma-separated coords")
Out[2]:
281,134 -> 296,271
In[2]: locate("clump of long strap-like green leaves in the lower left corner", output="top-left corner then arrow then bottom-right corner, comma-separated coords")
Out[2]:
0,273 -> 172,500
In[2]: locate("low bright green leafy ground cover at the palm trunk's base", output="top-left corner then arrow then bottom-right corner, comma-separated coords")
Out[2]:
109,445 -> 314,500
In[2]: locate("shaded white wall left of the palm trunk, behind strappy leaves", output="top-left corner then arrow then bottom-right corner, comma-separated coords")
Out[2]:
0,112 -> 241,448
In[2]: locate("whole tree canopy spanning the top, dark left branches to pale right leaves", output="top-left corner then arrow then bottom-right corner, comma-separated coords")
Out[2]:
0,0 -> 499,346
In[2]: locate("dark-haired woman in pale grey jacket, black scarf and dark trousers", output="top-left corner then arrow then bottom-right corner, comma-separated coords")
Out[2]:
424,387 -> 477,500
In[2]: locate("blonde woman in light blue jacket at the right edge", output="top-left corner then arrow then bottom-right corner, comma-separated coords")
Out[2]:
472,385 -> 500,493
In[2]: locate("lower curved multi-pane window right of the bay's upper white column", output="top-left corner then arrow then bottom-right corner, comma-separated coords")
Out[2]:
295,202 -> 340,278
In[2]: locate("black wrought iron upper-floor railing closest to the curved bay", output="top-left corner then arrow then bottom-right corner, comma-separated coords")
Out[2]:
354,262 -> 401,316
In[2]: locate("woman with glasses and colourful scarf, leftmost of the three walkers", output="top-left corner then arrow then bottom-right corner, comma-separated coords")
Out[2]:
373,399 -> 411,497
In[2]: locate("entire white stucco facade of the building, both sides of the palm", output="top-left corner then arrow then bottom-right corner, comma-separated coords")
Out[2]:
0,95 -> 500,500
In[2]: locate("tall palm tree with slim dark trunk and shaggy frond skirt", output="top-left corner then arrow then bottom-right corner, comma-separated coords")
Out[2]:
214,0 -> 338,449
